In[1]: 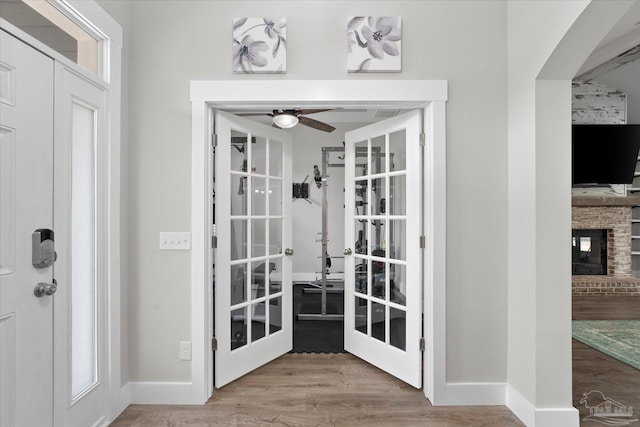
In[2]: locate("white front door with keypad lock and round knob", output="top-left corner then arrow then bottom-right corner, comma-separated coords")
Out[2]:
0,30 -> 55,426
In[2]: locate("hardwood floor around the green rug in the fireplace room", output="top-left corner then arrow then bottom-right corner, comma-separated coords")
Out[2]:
572,295 -> 640,426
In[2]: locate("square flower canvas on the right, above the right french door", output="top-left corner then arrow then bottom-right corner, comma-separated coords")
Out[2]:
347,16 -> 402,73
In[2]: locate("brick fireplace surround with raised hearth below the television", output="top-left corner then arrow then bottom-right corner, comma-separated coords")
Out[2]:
571,196 -> 640,296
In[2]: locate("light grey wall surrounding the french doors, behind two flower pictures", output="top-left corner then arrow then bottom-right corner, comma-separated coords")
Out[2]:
109,0 -> 507,382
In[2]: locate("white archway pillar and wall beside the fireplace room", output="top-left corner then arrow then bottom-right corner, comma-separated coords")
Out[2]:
507,1 -> 631,426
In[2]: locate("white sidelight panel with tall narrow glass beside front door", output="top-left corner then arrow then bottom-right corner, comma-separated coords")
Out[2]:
54,64 -> 109,427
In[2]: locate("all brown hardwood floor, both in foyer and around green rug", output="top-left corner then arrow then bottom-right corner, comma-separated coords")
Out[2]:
112,296 -> 640,427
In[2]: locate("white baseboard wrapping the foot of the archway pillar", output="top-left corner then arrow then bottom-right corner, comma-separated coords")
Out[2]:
506,384 -> 580,427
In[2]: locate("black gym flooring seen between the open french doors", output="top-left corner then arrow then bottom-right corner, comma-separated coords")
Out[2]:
291,284 -> 345,353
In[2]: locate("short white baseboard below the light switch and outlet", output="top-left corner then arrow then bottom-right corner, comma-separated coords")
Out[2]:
129,382 -> 194,405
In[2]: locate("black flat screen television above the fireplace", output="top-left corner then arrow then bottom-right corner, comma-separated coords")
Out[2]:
571,125 -> 640,187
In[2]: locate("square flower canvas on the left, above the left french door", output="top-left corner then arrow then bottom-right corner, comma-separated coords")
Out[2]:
233,18 -> 287,73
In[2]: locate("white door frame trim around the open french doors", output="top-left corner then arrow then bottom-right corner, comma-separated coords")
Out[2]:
190,80 -> 448,404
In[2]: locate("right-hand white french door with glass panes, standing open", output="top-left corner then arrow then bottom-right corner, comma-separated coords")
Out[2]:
344,111 -> 422,388
